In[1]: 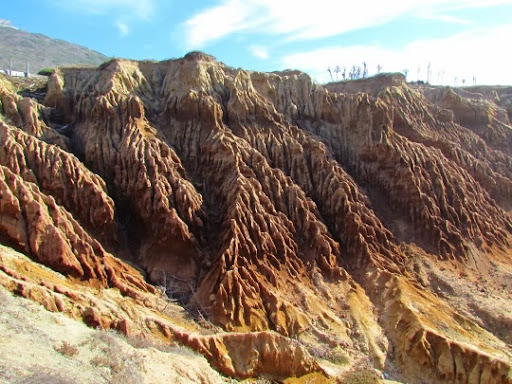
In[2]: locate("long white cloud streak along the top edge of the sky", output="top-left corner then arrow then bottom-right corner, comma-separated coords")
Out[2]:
183,0 -> 512,49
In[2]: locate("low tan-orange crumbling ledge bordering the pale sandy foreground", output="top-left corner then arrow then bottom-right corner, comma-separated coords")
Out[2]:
0,245 -> 324,379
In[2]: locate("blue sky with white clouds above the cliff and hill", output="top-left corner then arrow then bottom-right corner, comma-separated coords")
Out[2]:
0,0 -> 512,85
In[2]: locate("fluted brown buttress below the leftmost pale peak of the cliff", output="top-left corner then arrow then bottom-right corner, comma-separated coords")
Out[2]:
50,63 -> 203,280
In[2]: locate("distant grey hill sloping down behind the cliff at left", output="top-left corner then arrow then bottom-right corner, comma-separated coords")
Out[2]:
0,24 -> 109,73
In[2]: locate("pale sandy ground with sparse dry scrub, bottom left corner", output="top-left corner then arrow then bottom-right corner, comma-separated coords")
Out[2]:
0,286 -> 227,384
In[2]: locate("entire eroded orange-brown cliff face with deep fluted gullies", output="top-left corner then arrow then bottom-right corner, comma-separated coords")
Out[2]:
0,53 -> 512,383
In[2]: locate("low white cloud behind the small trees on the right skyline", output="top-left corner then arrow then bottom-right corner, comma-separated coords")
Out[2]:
282,24 -> 512,85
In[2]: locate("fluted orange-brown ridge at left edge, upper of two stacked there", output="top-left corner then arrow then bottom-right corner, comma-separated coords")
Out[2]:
0,122 -> 116,241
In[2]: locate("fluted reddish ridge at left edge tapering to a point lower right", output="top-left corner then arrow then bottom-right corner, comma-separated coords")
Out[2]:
0,165 -> 155,297
